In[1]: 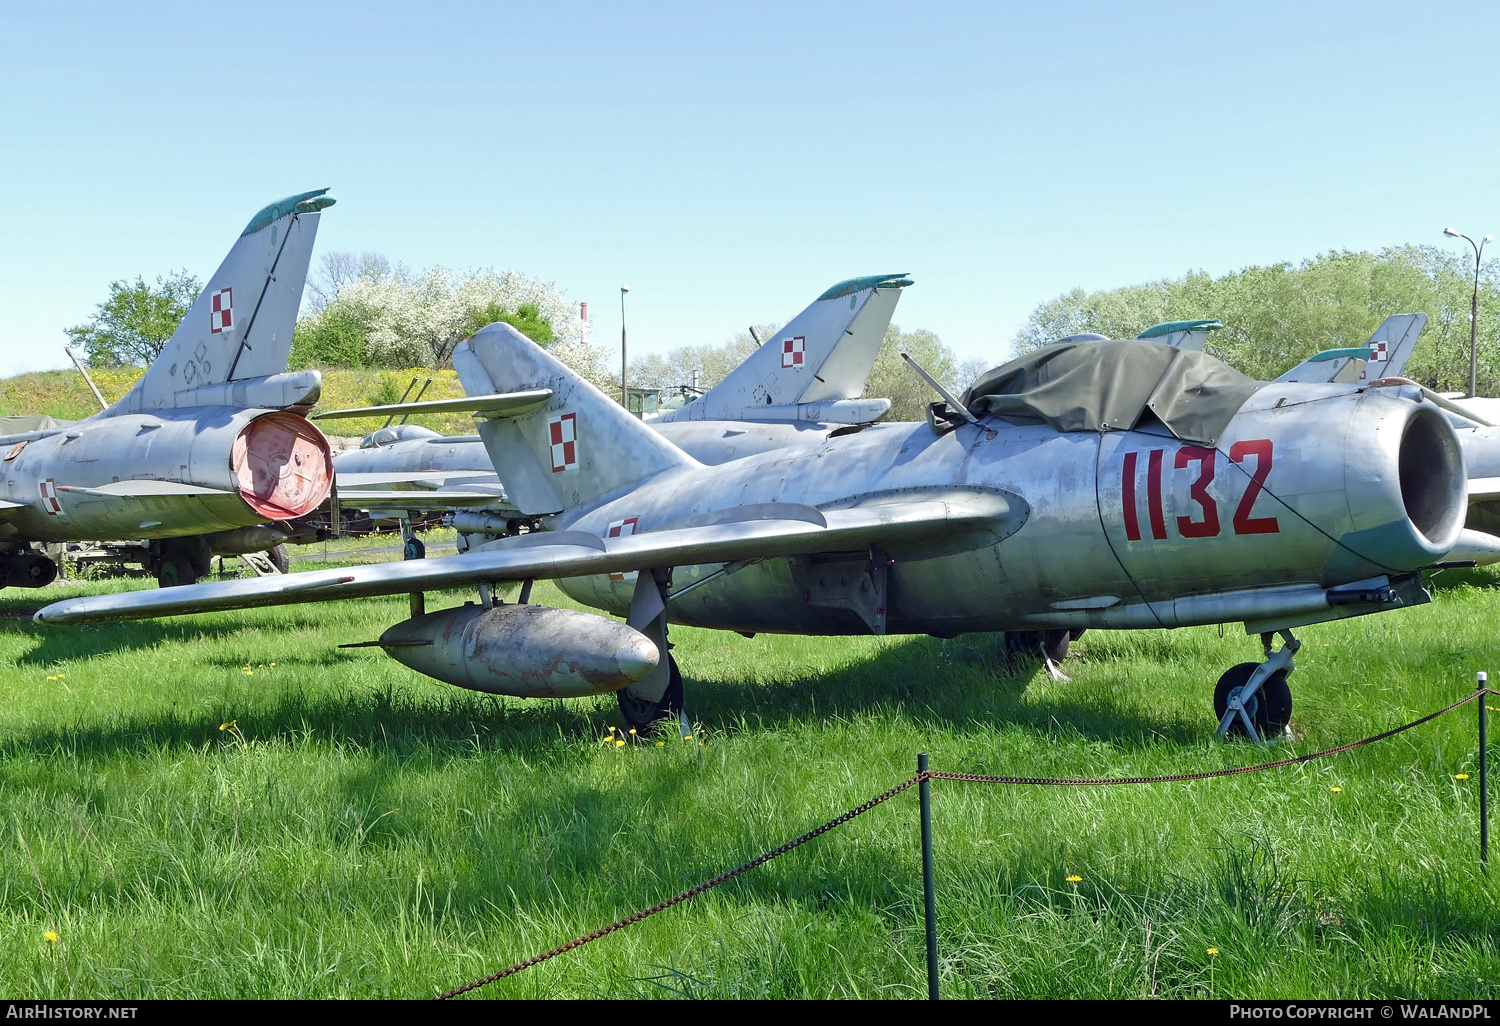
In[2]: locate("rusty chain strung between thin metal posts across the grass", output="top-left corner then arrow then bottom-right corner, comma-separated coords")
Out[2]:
432,687 -> 1500,1001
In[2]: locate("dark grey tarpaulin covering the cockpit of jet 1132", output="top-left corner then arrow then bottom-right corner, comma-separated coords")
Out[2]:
960,341 -> 1266,446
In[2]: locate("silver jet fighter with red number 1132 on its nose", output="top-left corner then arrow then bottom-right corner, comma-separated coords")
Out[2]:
36,324 -> 1466,735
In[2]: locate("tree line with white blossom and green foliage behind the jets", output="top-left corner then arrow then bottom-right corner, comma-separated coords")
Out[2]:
66,246 -> 1500,402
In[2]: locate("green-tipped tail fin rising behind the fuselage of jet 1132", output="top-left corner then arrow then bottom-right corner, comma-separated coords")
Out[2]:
656,275 -> 912,423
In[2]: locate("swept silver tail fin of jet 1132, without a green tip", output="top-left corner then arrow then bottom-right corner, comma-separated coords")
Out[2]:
453,324 -> 698,516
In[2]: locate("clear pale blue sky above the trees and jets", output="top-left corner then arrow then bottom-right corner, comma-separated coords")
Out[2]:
0,2 -> 1500,374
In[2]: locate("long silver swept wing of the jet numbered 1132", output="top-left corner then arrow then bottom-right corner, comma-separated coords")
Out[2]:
36,489 -> 1026,624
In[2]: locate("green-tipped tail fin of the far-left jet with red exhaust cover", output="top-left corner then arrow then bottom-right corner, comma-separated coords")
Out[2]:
111,189 -> 335,413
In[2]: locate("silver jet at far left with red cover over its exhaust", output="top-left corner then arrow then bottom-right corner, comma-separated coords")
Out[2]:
0,189 -> 335,588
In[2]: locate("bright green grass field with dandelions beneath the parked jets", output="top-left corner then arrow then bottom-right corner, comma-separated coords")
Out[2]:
0,554 -> 1500,998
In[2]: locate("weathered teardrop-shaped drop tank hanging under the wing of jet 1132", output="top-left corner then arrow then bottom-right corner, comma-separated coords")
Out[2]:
380,605 -> 660,698
